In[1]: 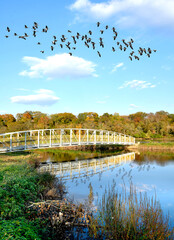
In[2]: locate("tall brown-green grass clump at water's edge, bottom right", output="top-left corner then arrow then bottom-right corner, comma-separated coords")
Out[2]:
89,185 -> 174,240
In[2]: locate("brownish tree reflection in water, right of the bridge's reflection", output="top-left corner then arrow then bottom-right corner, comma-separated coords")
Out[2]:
134,151 -> 174,166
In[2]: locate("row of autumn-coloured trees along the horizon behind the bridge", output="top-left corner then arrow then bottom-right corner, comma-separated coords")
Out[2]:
0,111 -> 174,138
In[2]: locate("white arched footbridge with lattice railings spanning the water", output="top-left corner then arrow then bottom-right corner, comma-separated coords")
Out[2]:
0,128 -> 135,152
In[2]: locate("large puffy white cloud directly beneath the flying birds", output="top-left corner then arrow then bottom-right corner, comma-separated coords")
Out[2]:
19,53 -> 98,80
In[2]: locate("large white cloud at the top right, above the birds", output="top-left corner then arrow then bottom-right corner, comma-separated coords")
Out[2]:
70,0 -> 174,26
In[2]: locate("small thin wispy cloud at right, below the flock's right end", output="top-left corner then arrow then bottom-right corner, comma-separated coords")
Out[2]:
119,80 -> 156,89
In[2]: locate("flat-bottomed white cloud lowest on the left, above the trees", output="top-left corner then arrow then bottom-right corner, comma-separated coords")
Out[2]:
11,89 -> 59,106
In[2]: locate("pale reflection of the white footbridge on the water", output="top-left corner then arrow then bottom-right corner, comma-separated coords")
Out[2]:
39,152 -> 135,180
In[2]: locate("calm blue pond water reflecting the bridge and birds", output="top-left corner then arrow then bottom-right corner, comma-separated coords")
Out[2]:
39,152 -> 174,225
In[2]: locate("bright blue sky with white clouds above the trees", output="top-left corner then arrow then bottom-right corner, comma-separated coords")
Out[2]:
0,0 -> 174,115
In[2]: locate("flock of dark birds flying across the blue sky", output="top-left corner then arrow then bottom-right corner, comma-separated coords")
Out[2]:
5,22 -> 157,61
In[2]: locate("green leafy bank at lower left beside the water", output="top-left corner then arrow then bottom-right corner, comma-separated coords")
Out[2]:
0,153 -> 67,240
